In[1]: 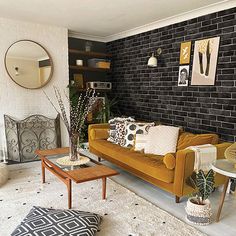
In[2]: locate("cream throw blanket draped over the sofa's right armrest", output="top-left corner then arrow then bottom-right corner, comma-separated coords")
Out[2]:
186,144 -> 217,172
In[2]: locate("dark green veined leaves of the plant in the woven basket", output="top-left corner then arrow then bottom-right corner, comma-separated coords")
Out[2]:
190,169 -> 215,204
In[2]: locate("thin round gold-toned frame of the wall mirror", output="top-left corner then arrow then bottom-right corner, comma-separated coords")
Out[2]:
4,39 -> 54,89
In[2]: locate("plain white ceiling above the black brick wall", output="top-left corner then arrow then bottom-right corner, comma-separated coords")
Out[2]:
0,0 -> 236,41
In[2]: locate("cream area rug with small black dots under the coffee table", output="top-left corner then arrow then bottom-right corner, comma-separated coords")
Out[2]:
0,162 -> 205,236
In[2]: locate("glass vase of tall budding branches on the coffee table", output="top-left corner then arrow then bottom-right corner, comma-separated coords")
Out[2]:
44,87 -> 96,161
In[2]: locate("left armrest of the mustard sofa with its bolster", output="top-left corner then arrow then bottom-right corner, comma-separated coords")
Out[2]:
88,124 -> 109,142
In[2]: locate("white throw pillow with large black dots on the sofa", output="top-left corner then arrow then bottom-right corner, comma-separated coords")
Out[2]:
123,122 -> 155,147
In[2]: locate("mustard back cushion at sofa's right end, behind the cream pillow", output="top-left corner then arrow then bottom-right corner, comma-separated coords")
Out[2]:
177,132 -> 219,150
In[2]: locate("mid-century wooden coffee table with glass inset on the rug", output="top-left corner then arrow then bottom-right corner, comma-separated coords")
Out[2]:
35,147 -> 119,209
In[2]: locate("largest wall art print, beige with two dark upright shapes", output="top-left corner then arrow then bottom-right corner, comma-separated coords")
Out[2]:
191,37 -> 220,85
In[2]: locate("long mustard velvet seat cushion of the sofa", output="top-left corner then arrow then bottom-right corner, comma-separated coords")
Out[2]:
89,140 -> 174,183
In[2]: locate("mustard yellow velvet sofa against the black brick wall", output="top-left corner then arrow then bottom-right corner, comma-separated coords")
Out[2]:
88,124 -> 231,203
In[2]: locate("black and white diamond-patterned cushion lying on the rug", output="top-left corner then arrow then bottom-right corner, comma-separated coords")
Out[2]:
11,207 -> 102,236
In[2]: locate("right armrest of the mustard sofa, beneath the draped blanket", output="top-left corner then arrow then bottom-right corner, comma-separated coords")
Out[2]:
173,143 -> 231,197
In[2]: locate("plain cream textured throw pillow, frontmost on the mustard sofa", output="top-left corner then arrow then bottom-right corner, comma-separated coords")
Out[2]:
144,125 -> 179,155
